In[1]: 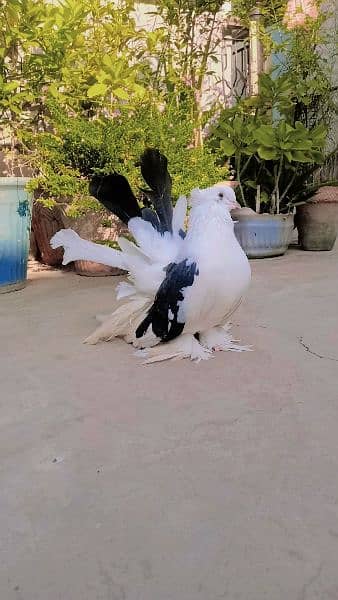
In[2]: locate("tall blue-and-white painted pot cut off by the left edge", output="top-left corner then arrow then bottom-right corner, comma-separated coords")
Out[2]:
0,177 -> 32,293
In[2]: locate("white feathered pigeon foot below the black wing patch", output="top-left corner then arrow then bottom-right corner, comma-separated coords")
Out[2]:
135,333 -> 212,365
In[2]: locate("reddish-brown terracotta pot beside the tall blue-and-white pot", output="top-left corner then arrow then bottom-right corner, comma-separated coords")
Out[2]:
32,201 -> 63,267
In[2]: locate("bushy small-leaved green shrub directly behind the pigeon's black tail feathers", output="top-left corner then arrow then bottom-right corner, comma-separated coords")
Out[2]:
25,99 -> 228,216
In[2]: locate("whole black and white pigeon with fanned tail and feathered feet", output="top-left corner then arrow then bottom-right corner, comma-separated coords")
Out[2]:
51,149 -> 251,363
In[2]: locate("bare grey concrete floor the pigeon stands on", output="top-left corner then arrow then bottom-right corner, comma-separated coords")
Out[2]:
0,250 -> 338,600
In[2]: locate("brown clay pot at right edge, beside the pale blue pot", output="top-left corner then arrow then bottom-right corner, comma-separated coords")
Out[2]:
295,186 -> 338,251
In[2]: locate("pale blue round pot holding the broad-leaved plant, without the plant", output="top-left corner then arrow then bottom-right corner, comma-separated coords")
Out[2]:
231,208 -> 294,258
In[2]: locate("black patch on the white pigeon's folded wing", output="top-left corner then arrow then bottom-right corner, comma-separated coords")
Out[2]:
136,259 -> 199,342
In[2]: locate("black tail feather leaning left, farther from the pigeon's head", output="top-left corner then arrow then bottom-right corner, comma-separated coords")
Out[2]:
89,173 -> 142,225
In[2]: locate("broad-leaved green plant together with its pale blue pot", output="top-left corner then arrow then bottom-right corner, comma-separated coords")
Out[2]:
211,74 -> 327,258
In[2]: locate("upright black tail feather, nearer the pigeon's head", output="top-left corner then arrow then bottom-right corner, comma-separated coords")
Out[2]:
140,148 -> 173,231
